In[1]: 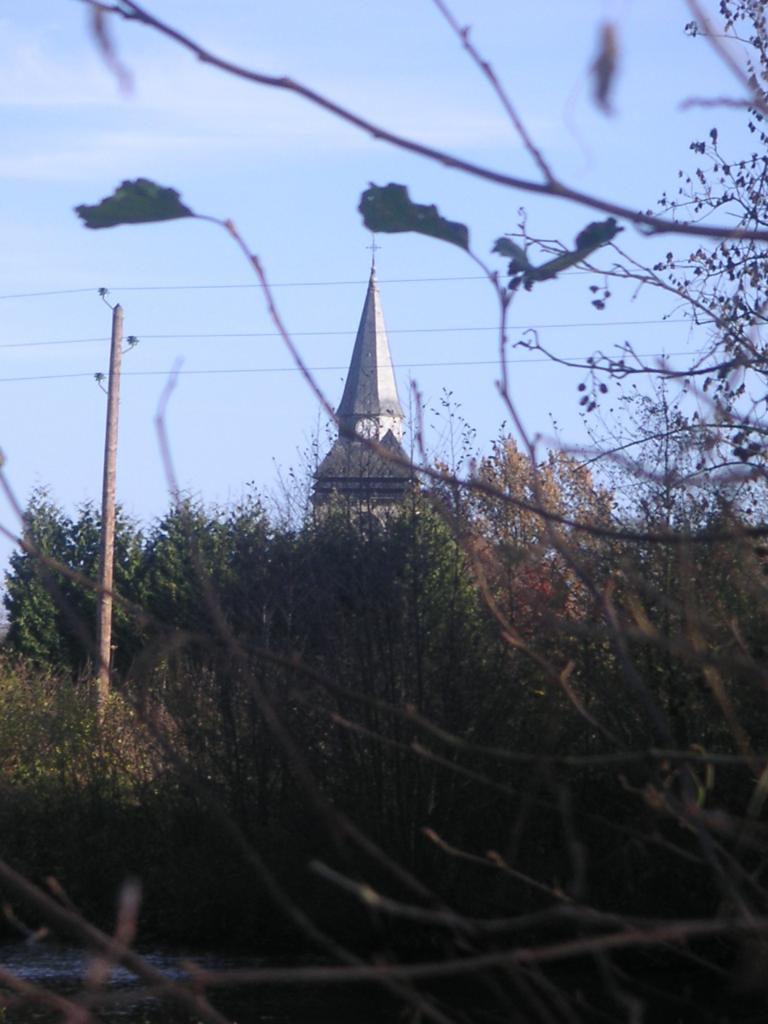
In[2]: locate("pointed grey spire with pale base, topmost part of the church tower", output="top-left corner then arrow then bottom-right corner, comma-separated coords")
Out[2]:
337,266 -> 404,441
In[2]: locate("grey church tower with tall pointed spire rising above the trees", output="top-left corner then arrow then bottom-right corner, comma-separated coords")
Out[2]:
312,267 -> 413,515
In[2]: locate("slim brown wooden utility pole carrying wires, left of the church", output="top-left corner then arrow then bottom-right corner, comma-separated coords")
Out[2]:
96,305 -> 123,708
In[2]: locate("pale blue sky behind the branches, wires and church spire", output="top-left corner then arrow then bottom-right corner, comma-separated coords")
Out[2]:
0,0 -> 744,560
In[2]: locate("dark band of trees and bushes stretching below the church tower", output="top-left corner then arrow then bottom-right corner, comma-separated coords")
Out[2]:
0,440 -> 768,1015
